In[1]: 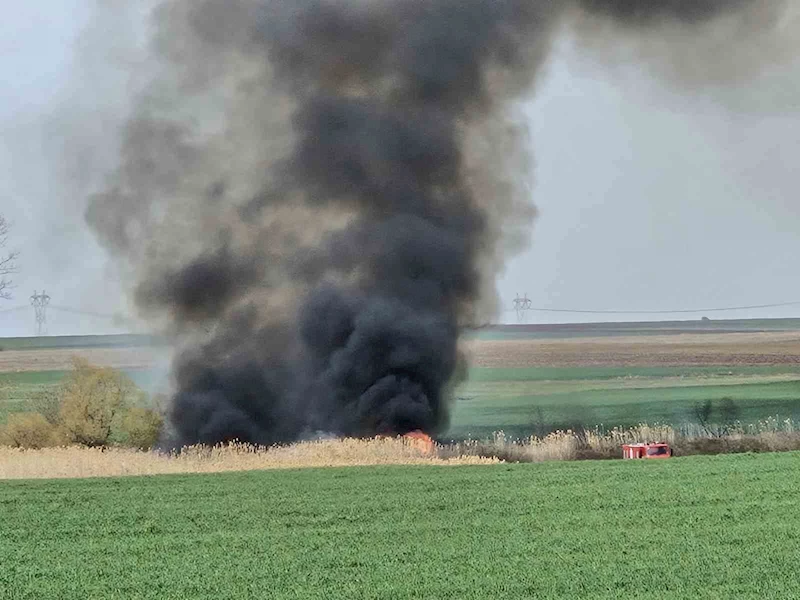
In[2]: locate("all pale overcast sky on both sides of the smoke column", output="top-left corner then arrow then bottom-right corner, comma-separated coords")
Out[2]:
0,0 -> 800,337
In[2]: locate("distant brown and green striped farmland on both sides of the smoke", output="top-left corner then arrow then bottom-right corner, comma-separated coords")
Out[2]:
0,319 -> 800,439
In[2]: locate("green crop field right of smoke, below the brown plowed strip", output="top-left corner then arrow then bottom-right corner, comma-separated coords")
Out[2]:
445,365 -> 800,438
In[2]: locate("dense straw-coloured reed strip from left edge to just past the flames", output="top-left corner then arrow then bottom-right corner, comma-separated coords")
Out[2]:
0,438 -> 499,479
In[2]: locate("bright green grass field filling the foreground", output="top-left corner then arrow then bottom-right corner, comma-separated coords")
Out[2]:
0,453 -> 800,600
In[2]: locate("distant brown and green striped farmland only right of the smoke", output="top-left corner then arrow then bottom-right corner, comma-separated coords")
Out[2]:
450,320 -> 800,438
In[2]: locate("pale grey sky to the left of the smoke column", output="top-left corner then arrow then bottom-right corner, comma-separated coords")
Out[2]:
0,0 -> 130,337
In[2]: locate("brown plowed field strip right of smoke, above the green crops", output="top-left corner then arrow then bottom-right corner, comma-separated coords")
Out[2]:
464,331 -> 800,368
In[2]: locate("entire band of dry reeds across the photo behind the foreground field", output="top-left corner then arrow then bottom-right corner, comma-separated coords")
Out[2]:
6,419 -> 800,479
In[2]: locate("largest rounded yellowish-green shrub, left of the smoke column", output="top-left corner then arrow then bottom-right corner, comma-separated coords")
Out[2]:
59,358 -> 139,446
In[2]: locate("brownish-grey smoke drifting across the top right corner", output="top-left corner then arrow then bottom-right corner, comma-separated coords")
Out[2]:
571,0 -> 800,86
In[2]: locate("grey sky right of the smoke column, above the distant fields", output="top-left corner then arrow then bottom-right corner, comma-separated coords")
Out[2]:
499,35 -> 800,322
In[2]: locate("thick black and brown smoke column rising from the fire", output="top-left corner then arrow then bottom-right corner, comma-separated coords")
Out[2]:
87,0 -> 796,445
